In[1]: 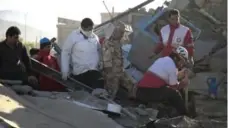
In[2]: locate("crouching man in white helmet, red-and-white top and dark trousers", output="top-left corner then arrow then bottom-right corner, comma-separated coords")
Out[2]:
136,50 -> 188,115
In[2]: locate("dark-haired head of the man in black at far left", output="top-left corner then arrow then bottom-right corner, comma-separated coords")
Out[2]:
6,26 -> 21,44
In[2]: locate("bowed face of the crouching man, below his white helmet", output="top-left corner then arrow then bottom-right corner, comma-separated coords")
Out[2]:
169,51 -> 186,69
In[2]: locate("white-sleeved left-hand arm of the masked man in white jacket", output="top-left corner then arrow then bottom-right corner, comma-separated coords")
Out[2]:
61,32 -> 77,76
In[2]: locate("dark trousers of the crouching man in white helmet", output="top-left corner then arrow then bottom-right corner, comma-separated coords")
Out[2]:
136,86 -> 187,115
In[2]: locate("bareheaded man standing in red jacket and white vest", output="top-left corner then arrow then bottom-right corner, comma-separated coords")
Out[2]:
149,9 -> 194,65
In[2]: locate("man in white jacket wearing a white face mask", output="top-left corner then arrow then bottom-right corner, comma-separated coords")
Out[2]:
61,18 -> 104,89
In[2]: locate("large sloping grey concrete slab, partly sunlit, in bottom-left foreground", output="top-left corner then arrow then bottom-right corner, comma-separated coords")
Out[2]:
0,85 -> 122,128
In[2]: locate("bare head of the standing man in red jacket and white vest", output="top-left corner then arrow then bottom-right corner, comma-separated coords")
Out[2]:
168,9 -> 180,25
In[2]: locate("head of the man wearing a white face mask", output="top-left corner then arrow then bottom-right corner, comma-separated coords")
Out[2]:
81,18 -> 94,37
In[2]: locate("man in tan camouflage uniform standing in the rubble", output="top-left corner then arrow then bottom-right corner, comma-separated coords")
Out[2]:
102,22 -> 135,98
